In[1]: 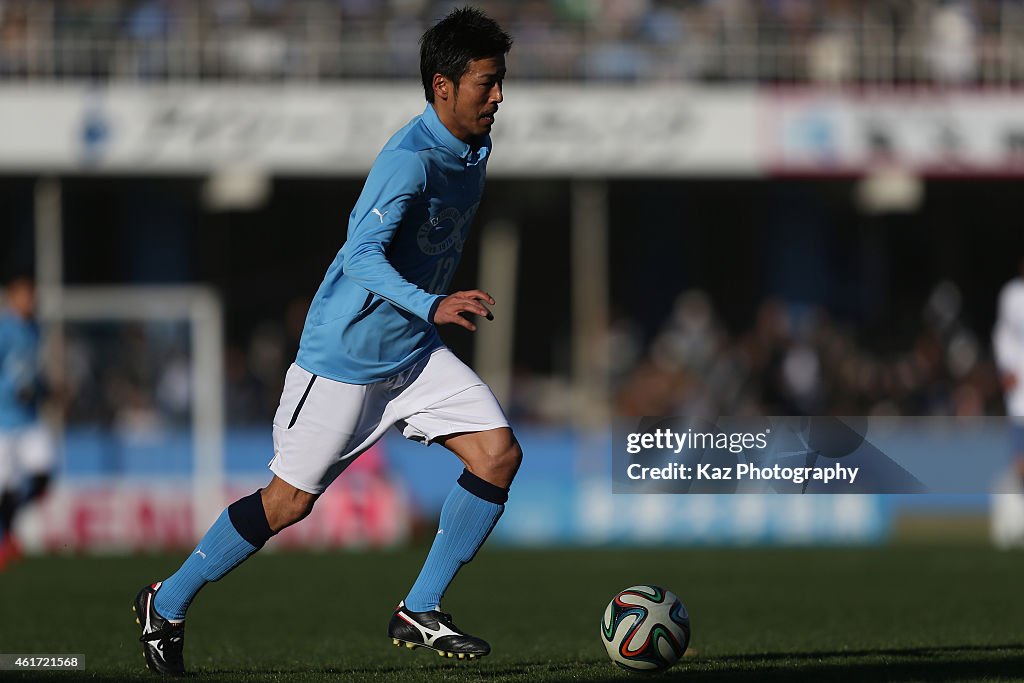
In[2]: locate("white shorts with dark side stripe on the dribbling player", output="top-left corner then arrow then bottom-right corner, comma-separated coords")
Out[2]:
270,347 -> 509,494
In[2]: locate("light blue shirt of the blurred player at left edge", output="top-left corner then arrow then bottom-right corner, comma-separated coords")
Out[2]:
0,309 -> 41,429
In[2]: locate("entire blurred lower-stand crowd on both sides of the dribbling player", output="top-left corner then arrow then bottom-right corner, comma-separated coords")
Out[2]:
54,283 -> 1004,439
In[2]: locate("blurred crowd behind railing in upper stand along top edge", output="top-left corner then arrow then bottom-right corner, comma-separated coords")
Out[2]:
0,0 -> 1024,83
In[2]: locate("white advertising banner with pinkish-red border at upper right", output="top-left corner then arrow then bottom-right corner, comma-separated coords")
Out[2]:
759,88 -> 1024,177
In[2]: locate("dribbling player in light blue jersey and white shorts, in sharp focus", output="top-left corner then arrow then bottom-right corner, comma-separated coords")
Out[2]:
133,8 -> 522,674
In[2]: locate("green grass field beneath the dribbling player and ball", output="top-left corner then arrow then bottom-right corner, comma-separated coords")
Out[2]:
0,544 -> 1024,683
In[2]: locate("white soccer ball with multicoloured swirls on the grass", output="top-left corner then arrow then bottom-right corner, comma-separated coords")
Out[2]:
601,586 -> 690,672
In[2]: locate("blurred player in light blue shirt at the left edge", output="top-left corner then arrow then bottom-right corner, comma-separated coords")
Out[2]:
0,275 -> 53,568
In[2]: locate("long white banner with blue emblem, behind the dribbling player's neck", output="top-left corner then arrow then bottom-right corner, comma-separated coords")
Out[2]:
0,82 -> 757,176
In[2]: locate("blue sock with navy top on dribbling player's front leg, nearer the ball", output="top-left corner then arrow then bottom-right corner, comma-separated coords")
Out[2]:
406,470 -> 509,612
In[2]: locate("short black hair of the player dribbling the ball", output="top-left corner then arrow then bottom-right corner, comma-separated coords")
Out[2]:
420,7 -> 512,102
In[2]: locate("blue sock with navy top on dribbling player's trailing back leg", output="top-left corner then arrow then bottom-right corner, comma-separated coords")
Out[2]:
154,490 -> 273,621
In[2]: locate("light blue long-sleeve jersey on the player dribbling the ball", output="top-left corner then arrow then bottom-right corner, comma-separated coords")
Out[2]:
296,104 -> 490,384
